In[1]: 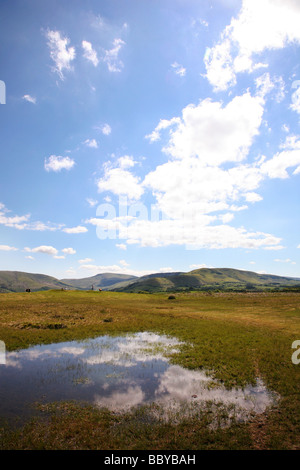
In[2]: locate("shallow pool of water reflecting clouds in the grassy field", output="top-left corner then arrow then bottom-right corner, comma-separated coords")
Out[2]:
0,332 -> 274,422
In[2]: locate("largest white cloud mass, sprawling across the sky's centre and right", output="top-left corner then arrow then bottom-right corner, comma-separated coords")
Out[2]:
90,86 -> 300,250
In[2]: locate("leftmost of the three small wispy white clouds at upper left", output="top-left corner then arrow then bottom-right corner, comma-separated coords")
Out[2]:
46,30 -> 76,80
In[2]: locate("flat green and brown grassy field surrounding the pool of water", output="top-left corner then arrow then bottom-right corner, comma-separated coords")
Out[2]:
0,291 -> 300,450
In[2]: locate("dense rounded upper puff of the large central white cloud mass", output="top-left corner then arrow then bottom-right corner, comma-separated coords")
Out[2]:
150,93 -> 264,165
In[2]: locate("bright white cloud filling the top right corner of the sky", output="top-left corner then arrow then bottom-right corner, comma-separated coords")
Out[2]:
204,0 -> 300,91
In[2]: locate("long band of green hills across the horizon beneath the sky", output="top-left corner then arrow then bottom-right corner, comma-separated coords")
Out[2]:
0,268 -> 300,293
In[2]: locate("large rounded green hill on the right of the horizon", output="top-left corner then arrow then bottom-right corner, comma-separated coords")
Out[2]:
113,268 -> 300,292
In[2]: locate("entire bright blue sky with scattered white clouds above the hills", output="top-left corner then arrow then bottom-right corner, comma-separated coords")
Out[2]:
0,0 -> 300,279
